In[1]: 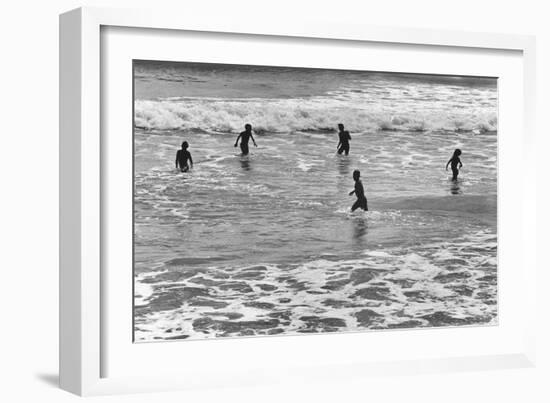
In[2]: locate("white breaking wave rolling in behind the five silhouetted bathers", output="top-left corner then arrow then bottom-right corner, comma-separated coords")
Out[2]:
134,97 -> 497,133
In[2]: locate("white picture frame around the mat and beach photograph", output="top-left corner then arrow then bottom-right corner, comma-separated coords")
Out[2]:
60,8 -> 537,395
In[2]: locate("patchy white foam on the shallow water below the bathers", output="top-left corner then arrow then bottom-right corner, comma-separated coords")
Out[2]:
136,231 -> 496,341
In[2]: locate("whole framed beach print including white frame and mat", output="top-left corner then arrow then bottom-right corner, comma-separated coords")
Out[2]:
60,9 -> 536,394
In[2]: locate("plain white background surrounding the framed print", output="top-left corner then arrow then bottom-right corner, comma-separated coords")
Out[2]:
0,0 -> 550,403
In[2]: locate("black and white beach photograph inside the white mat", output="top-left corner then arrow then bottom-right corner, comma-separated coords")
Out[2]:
133,60 -> 498,342
